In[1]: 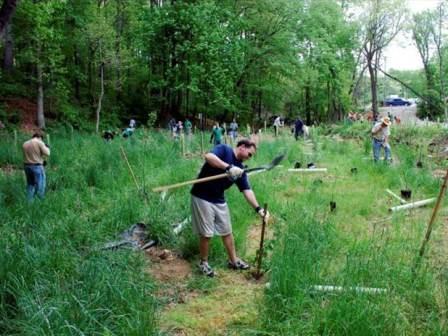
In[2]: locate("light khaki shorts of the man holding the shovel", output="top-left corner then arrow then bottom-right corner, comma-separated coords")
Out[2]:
191,195 -> 232,237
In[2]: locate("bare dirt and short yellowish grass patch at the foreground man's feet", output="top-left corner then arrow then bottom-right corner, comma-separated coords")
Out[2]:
148,224 -> 273,336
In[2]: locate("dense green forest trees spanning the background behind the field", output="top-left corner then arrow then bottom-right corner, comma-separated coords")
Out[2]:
0,0 -> 448,131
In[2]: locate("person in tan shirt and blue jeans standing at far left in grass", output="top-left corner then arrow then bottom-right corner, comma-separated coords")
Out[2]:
22,132 -> 50,201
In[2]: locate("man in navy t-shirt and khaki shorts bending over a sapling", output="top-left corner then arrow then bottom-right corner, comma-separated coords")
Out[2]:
191,139 -> 268,277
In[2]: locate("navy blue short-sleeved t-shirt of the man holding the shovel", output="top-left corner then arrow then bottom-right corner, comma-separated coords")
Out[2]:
191,145 -> 250,203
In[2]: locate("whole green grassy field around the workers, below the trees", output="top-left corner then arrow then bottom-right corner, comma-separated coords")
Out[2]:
0,124 -> 448,335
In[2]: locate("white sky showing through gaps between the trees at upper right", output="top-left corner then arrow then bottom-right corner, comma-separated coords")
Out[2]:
383,0 -> 443,71
